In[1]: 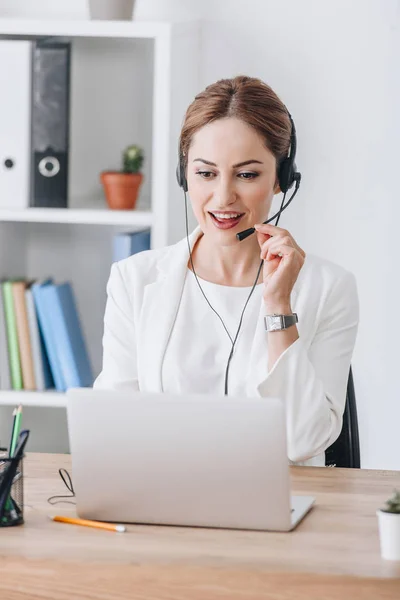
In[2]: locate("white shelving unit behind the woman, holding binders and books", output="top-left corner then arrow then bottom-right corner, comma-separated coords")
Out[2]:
0,19 -> 200,449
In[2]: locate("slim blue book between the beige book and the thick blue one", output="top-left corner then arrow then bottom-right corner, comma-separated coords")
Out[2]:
31,279 -> 65,392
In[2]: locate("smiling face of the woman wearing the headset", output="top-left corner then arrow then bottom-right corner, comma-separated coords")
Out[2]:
187,118 -> 279,245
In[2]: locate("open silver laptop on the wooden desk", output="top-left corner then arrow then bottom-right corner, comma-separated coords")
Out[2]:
67,388 -> 314,531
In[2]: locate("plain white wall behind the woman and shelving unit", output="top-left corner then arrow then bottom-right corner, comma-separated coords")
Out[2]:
0,0 -> 400,469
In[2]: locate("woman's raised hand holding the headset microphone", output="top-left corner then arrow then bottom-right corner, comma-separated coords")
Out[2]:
254,224 -> 306,314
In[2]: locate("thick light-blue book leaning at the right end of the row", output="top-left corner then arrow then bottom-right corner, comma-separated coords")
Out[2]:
41,283 -> 94,391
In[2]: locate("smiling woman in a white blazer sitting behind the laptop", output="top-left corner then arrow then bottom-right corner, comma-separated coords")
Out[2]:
95,77 -> 358,465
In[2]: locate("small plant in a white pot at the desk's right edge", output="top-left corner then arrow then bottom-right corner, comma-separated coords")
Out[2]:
377,490 -> 400,560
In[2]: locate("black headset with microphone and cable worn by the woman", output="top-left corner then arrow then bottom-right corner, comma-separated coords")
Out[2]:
176,109 -> 301,395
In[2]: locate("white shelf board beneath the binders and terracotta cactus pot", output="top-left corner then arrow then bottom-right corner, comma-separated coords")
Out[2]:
0,204 -> 153,227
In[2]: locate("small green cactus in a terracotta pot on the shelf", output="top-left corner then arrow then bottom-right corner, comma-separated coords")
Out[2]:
100,146 -> 143,210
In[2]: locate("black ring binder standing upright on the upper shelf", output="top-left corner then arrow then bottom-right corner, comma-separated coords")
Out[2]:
30,41 -> 71,208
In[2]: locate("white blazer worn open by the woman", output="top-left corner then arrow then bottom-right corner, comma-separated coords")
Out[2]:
94,228 -> 359,465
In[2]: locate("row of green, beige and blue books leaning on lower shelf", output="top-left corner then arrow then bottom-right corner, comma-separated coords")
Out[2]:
0,279 -> 93,392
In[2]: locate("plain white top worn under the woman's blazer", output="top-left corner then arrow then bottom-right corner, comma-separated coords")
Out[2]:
162,269 -> 267,397
